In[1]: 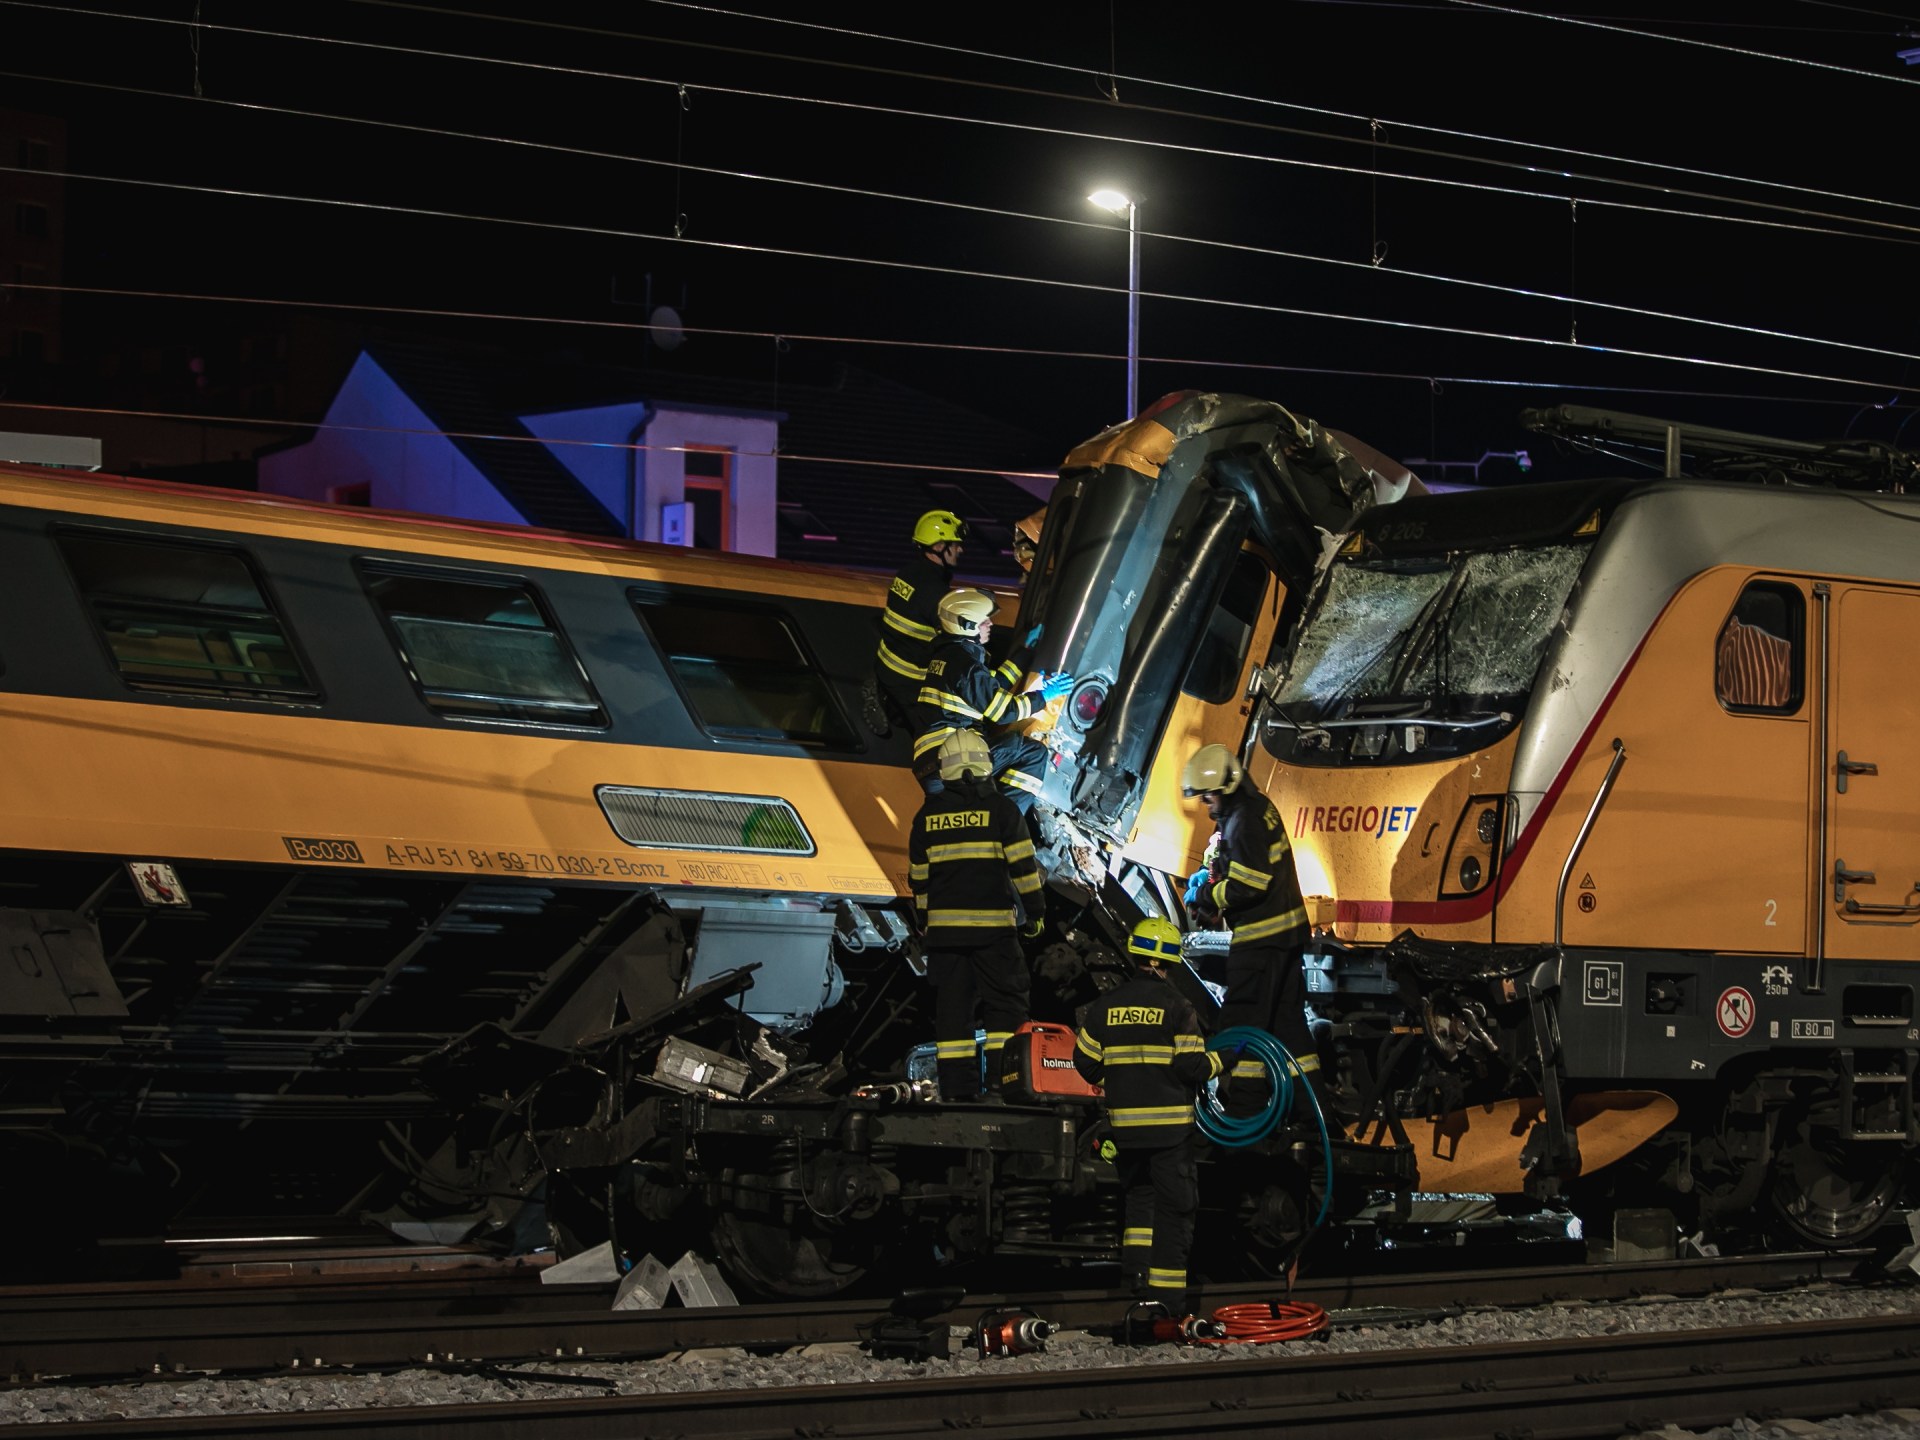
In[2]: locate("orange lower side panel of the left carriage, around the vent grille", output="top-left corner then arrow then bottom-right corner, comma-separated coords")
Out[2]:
0,695 -> 920,899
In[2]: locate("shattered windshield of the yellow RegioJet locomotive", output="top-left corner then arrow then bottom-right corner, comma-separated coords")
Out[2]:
1277,545 -> 1588,722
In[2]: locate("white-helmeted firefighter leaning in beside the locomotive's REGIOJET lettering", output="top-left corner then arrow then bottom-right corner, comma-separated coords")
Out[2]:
1181,745 -> 1321,1114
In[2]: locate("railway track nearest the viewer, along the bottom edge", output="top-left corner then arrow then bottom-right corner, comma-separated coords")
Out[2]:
22,1315 -> 1920,1440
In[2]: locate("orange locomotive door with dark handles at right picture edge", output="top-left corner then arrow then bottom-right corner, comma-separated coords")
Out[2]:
1820,586 -> 1920,960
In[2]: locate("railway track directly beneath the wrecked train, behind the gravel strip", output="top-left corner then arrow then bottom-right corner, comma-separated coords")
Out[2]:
0,1250 -> 1874,1384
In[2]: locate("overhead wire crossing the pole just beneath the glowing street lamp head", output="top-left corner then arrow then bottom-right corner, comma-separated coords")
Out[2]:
0,71 -> 1920,374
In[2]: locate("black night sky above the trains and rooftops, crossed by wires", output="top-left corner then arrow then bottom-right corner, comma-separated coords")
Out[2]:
0,0 -> 1920,485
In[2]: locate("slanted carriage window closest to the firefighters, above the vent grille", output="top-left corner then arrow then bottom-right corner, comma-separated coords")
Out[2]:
630,591 -> 856,749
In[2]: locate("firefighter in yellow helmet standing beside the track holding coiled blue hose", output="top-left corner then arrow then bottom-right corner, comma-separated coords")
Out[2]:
1073,916 -> 1221,1317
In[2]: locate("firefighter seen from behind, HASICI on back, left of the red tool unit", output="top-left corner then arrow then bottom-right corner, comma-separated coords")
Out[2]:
906,730 -> 1041,1100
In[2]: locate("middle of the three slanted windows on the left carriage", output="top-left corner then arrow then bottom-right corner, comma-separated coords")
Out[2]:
363,564 -> 607,728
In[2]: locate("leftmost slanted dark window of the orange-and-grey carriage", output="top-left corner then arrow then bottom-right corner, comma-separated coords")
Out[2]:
54,532 -> 319,701
